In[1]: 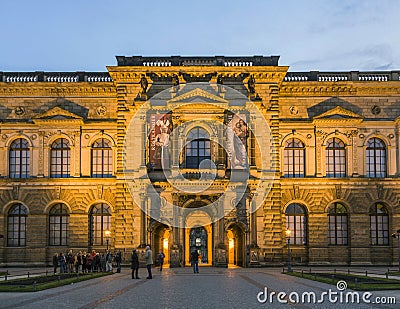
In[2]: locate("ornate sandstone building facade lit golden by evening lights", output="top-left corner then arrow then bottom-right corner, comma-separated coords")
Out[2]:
0,56 -> 400,266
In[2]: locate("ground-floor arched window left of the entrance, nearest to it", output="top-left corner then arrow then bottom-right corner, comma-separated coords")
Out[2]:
89,203 -> 111,246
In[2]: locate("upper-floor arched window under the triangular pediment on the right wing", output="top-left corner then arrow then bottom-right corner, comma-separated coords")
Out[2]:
326,137 -> 346,177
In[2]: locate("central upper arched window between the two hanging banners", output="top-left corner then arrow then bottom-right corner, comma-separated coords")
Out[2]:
186,127 -> 211,168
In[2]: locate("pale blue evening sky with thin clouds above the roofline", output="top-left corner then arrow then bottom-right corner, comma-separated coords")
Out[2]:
0,0 -> 400,71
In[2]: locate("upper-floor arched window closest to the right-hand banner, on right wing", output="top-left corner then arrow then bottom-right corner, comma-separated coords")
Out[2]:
284,138 -> 305,177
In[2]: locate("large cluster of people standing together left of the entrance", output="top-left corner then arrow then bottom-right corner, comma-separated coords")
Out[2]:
53,249 -> 122,274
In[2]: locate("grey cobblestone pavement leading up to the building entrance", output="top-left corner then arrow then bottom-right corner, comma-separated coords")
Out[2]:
0,267 -> 400,309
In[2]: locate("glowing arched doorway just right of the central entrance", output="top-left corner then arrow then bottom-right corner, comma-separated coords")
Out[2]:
226,224 -> 246,267
